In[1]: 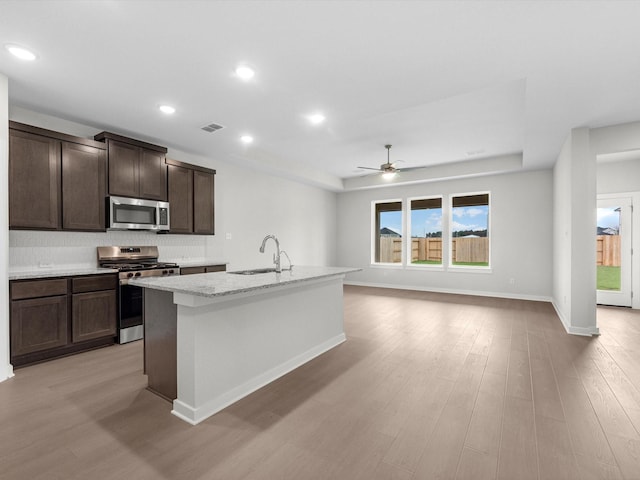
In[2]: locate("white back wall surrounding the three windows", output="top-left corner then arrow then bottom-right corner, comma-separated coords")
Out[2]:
338,170 -> 552,300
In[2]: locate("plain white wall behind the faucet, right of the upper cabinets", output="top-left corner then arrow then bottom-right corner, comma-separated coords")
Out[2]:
206,158 -> 336,269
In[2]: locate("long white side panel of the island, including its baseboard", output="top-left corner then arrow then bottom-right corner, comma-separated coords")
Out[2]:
173,276 -> 346,424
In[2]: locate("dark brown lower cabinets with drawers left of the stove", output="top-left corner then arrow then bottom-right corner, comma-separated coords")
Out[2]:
10,274 -> 118,367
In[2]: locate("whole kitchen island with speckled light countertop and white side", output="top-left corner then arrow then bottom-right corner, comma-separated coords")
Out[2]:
131,266 -> 358,425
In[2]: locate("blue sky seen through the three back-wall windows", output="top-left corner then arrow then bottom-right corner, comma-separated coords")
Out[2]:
380,205 -> 489,237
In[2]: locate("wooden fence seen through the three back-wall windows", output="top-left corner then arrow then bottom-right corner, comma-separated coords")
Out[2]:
380,237 -> 489,263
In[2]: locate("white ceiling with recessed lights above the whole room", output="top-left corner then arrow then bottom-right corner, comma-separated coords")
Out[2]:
0,0 -> 640,189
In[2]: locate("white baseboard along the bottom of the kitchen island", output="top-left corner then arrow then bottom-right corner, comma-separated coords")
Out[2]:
171,333 -> 347,425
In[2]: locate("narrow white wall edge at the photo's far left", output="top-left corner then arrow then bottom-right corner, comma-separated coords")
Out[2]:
0,74 -> 13,382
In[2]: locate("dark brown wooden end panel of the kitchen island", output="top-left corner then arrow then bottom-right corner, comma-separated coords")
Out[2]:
144,288 -> 178,401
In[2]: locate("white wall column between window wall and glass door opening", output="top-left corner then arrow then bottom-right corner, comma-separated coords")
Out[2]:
553,128 -> 598,335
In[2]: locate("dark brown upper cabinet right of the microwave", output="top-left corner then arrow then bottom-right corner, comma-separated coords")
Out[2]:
166,159 -> 216,235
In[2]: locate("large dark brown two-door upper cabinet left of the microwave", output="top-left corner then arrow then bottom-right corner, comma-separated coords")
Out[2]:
9,122 -> 106,231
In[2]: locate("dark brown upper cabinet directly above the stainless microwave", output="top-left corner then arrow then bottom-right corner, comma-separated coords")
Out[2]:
94,132 -> 167,201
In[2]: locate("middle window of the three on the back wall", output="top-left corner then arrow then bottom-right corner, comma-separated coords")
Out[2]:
407,197 -> 442,265
